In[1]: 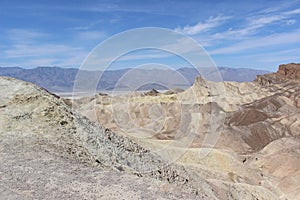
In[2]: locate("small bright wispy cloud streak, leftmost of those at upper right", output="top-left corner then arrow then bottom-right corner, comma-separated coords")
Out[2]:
175,16 -> 230,35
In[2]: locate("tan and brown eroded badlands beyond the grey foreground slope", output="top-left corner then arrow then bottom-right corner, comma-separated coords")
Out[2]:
73,64 -> 300,199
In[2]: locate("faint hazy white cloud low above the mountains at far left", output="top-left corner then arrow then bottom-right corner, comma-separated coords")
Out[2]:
0,29 -> 90,66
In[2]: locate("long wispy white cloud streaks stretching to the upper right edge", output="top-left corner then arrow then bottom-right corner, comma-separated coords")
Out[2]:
175,6 -> 300,46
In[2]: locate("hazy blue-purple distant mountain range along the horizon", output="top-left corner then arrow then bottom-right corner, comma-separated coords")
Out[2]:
0,67 -> 270,92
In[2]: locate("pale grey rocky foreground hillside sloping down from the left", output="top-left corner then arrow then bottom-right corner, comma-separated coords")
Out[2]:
0,77 -> 286,199
